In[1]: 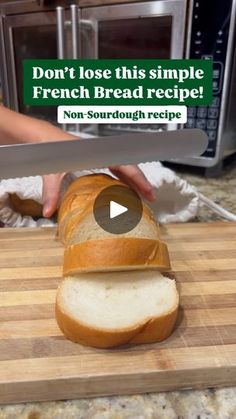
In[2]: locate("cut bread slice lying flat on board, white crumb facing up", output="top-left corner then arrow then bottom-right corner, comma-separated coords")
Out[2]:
56,271 -> 179,348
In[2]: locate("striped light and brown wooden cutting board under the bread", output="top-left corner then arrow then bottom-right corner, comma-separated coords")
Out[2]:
0,223 -> 236,403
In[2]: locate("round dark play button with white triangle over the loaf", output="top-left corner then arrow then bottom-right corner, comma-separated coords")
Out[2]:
93,185 -> 143,234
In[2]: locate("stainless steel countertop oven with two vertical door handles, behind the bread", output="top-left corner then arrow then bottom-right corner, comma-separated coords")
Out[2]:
0,0 -> 236,168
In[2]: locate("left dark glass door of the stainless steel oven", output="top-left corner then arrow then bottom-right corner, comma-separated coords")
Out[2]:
0,0 -> 75,122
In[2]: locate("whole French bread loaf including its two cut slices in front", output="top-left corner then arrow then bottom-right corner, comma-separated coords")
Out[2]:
56,174 -> 179,348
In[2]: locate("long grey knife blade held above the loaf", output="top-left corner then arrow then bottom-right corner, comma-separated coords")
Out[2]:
0,129 -> 208,179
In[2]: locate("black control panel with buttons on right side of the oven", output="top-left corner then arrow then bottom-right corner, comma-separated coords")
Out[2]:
185,0 -> 232,158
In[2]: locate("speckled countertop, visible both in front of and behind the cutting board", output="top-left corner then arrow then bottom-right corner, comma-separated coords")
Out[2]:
0,160 -> 236,419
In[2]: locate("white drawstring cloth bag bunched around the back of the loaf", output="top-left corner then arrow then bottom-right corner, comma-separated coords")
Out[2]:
0,162 -> 236,227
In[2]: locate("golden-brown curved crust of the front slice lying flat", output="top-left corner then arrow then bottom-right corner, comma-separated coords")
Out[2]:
55,288 -> 179,349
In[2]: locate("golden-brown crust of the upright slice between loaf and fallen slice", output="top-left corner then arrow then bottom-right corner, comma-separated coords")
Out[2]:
63,237 -> 171,276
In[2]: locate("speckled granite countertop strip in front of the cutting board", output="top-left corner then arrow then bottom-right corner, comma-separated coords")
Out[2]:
0,388 -> 236,419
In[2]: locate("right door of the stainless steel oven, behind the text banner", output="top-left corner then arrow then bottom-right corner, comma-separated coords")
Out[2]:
80,0 -> 186,135
